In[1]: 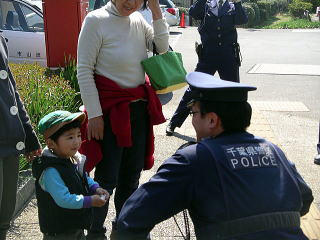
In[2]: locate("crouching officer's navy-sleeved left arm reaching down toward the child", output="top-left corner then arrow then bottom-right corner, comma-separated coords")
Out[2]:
112,154 -> 194,240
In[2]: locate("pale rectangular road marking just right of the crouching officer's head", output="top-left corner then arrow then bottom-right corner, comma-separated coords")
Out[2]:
249,101 -> 310,112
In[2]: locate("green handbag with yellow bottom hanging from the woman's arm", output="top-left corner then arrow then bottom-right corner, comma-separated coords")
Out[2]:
141,46 -> 187,94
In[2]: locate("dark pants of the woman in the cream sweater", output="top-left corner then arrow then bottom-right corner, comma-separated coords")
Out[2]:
90,101 -> 148,233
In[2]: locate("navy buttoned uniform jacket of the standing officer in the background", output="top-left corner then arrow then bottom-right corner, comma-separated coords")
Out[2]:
189,0 -> 248,64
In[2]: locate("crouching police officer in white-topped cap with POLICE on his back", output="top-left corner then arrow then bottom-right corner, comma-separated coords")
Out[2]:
112,72 -> 313,240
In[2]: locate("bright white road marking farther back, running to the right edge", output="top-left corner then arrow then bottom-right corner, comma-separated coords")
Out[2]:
248,63 -> 320,76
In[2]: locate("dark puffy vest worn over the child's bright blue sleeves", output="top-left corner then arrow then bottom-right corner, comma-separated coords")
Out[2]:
32,156 -> 92,235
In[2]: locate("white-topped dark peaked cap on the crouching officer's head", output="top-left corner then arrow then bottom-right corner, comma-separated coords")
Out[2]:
186,72 -> 257,102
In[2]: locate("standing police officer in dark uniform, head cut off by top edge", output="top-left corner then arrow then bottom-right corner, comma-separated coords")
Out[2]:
166,0 -> 248,136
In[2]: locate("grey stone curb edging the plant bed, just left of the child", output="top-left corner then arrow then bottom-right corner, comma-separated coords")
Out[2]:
12,177 -> 35,220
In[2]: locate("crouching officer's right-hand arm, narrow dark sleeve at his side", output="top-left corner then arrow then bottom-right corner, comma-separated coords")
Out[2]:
291,163 -> 313,216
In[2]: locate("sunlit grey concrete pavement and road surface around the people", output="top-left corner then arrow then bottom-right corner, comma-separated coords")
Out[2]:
9,27 -> 320,240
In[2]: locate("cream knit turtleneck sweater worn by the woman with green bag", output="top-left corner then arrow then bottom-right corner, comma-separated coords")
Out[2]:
77,1 -> 169,119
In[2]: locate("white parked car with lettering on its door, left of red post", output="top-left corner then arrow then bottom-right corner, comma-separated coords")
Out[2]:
0,0 -> 47,66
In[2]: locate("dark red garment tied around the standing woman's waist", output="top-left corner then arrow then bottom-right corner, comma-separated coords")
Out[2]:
79,75 -> 166,172
